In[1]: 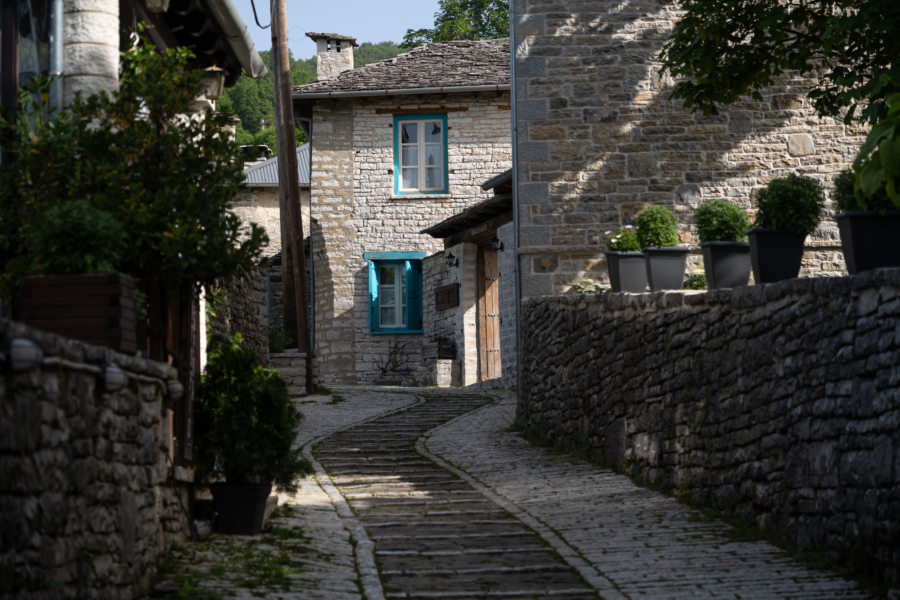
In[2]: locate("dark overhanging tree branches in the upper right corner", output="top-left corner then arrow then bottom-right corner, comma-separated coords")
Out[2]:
660,0 -> 900,123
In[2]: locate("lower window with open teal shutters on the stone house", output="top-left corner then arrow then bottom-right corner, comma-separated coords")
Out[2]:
363,252 -> 425,333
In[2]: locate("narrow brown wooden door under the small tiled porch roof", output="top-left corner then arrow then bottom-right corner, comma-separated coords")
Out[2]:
477,242 -> 500,381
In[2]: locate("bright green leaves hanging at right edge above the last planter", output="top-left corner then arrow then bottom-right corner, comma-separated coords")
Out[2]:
853,90 -> 900,210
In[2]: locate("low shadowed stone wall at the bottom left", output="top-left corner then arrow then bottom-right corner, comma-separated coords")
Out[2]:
0,319 -> 188,600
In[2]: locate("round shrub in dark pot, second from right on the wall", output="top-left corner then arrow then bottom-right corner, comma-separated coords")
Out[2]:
747,173 -> 825,283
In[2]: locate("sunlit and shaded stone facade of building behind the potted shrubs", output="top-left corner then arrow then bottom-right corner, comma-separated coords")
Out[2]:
513,0 -> 863,297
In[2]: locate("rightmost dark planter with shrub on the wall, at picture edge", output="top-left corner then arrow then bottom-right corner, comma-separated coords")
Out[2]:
834,169 -> 900,275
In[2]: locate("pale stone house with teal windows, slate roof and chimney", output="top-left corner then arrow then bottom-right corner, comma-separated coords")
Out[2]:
293,33 -> 511,384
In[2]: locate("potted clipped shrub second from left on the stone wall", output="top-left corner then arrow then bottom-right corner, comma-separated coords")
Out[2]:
637,205 -> 690,292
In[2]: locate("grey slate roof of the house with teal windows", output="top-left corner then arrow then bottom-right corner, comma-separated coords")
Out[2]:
293,38 -> 509,100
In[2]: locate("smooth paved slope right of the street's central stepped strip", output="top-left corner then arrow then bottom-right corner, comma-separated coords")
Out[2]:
423,394 -> 868,600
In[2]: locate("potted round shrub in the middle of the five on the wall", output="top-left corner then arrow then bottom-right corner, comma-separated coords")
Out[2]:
695,200 -> 750,289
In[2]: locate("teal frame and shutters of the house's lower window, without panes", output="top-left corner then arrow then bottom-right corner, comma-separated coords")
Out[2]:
363,252 -> 426,335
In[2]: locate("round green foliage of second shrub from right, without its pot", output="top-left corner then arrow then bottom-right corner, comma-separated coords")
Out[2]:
755,173 -> 825,235
